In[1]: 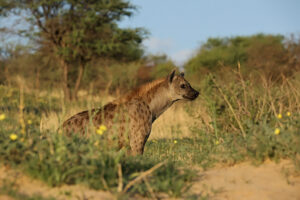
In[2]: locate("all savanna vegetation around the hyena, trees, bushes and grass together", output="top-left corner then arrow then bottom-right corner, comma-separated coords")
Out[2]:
0,0 -> 300,199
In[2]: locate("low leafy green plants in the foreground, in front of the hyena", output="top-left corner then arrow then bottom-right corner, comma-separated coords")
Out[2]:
0,131 -> 195,196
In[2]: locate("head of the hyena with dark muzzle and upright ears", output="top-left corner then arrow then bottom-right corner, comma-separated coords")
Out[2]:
167,70 -> 199,101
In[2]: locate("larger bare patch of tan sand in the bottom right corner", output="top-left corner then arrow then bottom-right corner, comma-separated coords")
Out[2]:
192,161 -> 300,200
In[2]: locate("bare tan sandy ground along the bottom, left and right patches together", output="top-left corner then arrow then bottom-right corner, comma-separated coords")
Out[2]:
0,161 -> 300,200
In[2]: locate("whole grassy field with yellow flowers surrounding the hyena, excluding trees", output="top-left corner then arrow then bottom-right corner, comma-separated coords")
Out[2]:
0,69 -> 300,199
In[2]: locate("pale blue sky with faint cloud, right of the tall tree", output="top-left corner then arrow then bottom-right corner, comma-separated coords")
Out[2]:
120,0 -> 300,65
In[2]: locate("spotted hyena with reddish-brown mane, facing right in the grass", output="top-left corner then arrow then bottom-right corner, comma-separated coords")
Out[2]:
63,70 -> 199,155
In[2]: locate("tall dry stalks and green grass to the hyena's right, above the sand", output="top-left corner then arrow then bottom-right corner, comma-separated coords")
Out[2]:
145,70 -> 300,170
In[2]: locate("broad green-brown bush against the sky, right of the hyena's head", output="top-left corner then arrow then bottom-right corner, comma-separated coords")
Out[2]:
185,34 -> 299,78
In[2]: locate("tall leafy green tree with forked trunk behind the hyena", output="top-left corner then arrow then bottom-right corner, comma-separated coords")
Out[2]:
0,0 -> 146,100
